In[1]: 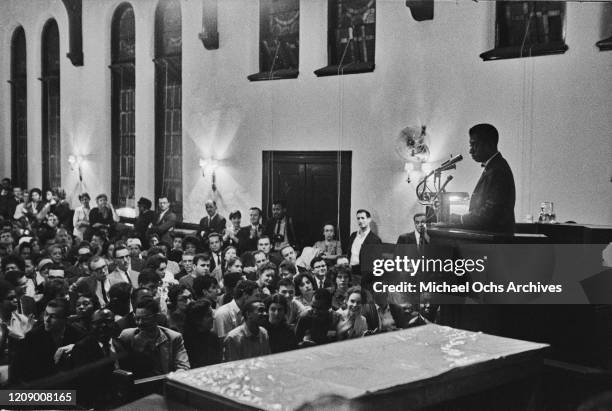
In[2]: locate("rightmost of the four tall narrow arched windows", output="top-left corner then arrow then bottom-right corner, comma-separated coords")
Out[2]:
155,0 -> 183,218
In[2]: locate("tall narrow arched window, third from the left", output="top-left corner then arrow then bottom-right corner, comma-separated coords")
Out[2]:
110,3 -> 136,207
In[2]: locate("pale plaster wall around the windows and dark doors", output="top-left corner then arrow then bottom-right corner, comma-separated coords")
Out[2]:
0,0 -> 612,241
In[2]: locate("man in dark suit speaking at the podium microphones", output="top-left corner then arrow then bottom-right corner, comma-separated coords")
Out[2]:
450,124 -> 516,233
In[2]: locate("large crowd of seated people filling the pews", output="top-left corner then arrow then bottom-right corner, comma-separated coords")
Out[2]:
0,179 -> 432,404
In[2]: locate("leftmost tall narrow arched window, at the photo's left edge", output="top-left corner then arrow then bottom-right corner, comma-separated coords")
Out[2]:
11,27 -> 28,188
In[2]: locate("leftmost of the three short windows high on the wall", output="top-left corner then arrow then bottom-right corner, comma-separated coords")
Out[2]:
248,0 -> 300,81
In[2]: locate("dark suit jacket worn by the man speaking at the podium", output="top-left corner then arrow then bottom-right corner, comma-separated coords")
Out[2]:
462,153 -> 516,233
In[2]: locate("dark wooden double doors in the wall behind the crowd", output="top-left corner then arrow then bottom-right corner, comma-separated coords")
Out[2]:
262,151 -> 352,250
